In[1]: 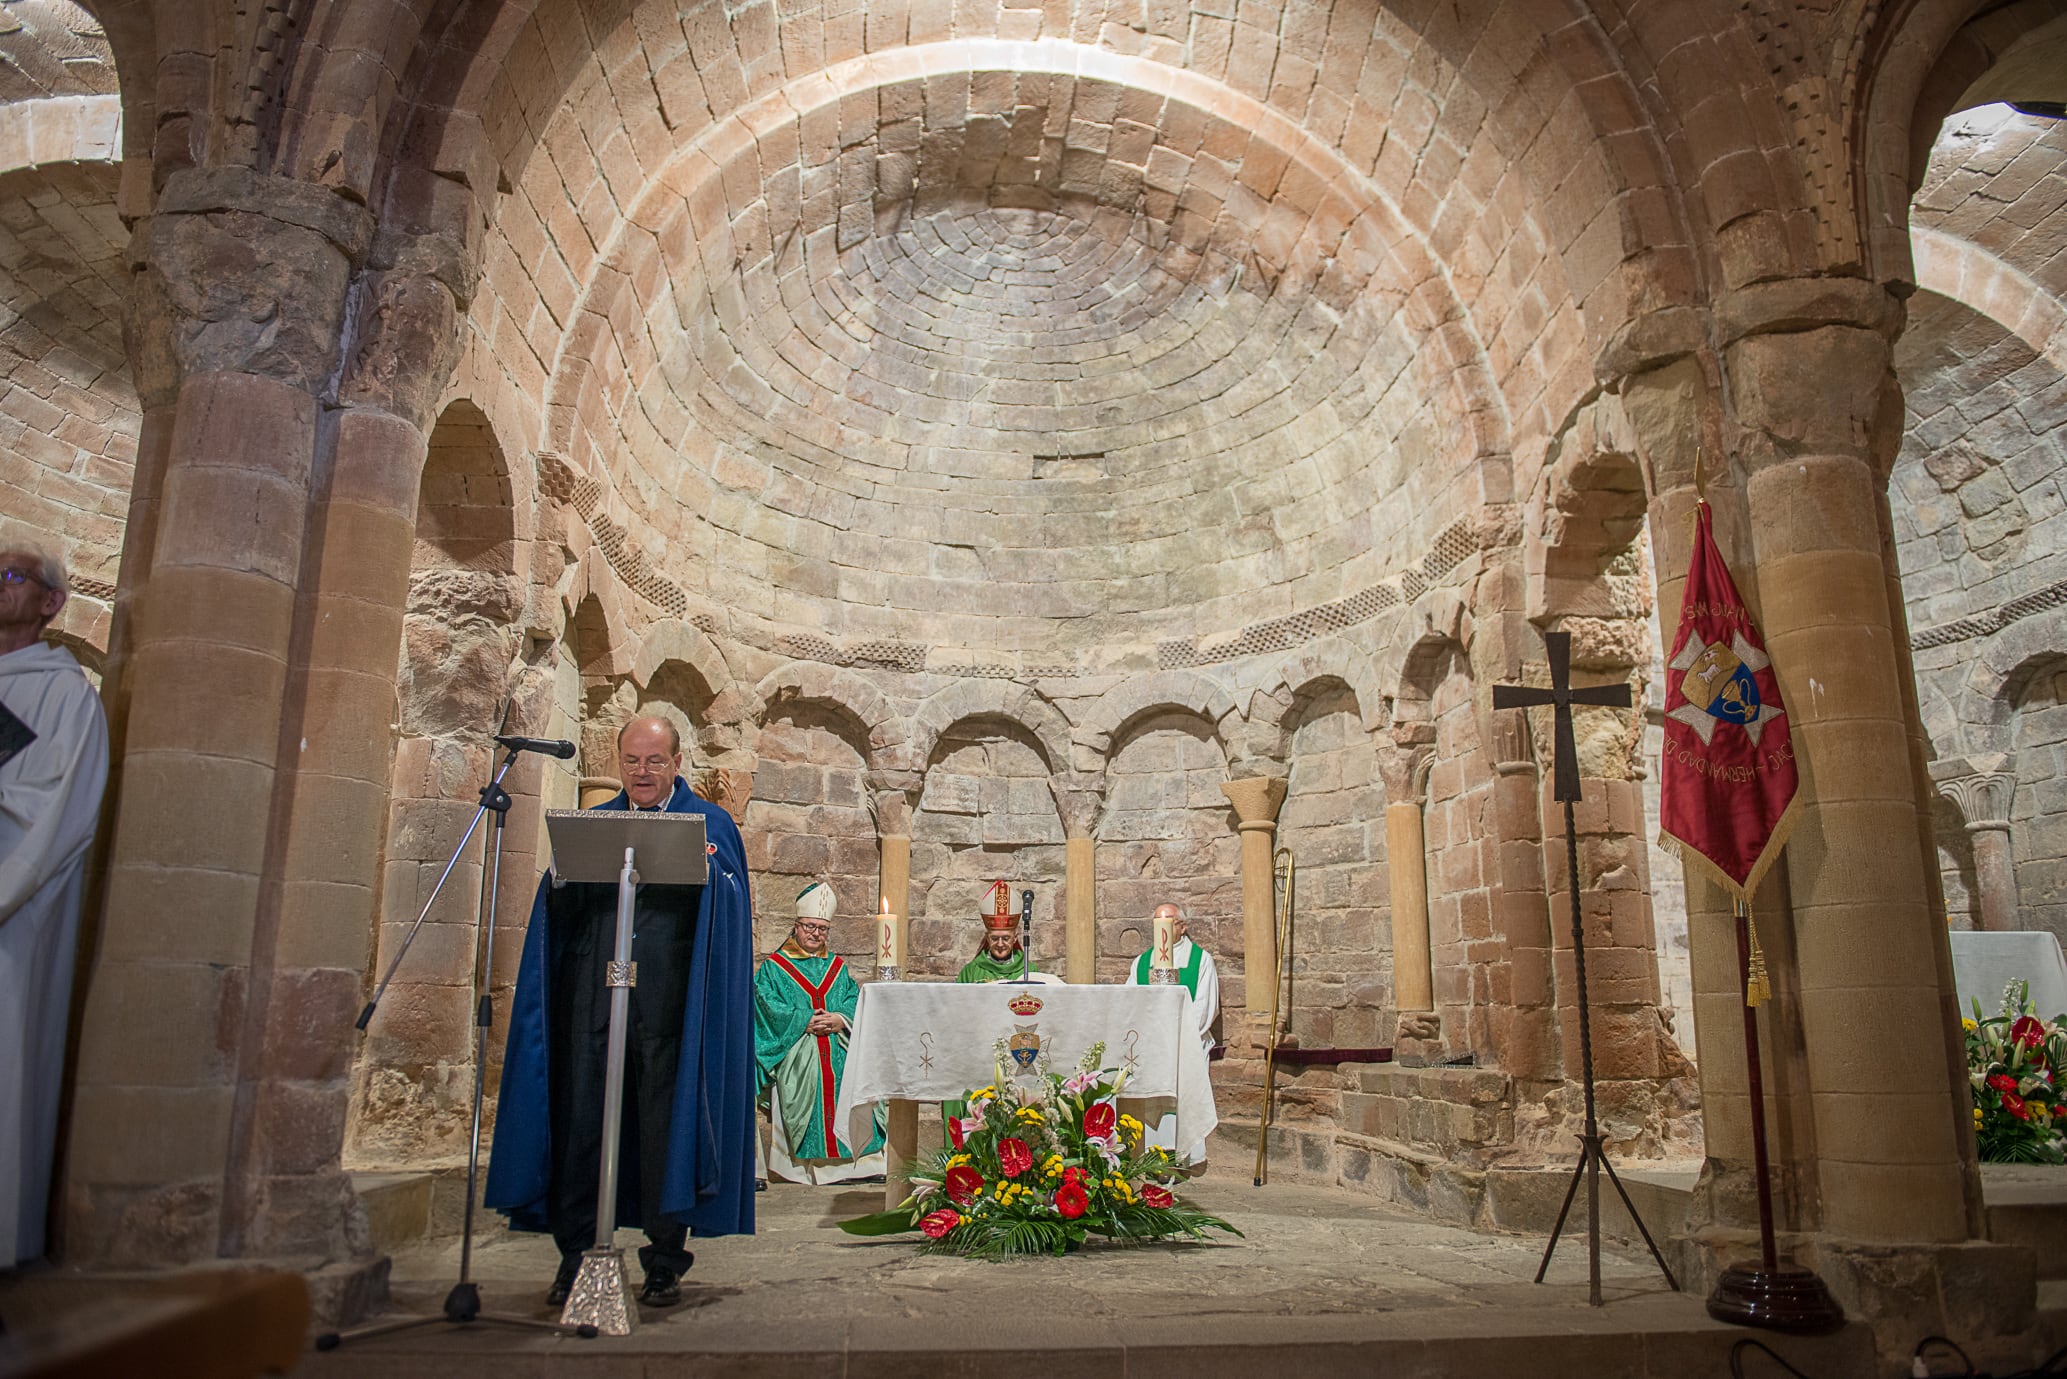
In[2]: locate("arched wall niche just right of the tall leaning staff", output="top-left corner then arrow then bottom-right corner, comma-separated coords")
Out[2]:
1277,682 -> 1393,1048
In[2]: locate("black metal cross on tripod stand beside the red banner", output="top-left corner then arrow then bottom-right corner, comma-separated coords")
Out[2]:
1492,633 -> 1678,1307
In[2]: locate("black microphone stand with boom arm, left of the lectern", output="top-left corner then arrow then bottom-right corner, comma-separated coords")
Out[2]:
316,738 -> 595,1350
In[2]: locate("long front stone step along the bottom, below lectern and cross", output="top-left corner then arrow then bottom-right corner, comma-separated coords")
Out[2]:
296,1298 -> 1875,1379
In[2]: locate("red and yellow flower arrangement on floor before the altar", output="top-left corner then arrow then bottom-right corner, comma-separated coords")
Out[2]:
841,1044 -> 1242,1259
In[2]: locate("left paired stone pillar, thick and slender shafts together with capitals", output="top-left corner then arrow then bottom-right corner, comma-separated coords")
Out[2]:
64,170 -> 465,1311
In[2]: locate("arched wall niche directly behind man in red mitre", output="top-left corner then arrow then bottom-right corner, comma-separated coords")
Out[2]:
907,719 -> 1062,976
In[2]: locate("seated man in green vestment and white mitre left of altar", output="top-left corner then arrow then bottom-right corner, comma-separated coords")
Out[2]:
754,881 -> 883,1185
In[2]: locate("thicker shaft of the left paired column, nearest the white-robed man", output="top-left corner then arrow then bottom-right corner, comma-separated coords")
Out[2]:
66,170 -> 376,1265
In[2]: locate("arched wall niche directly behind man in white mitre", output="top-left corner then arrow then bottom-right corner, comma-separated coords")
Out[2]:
742,701 -> 881,976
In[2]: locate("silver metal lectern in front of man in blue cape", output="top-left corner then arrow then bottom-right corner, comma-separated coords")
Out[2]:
546,808 -> 711,1336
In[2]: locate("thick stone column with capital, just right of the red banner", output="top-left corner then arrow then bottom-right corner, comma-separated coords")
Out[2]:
1718,279 -> 1968,1243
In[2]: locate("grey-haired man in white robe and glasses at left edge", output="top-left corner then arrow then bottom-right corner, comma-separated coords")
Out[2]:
0,548 -> 107,1265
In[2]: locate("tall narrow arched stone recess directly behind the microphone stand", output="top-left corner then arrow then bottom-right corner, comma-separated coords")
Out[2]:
347,401 -> 516,1164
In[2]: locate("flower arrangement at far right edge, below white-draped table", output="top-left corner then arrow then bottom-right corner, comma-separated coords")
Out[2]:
1960,982 -> 2067,1164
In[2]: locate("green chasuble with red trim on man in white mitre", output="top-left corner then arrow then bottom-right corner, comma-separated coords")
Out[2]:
754,943 -> 883,1162
